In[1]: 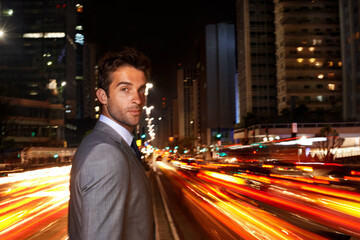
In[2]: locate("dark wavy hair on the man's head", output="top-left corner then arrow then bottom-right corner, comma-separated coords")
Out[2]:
98,47 -> 151,94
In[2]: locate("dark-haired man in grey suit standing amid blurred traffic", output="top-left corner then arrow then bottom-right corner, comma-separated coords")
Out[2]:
69,49 -> 154,240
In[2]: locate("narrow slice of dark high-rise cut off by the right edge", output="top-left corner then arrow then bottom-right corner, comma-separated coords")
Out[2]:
339,0 -> 360,121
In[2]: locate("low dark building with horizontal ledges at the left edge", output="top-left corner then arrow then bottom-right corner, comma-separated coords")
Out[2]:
0,97 -> 67,148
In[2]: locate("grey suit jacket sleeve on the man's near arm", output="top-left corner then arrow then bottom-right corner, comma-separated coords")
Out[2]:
78,144 -> 129,240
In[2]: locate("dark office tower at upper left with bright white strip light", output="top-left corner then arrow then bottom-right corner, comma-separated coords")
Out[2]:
0,0 -> 76,110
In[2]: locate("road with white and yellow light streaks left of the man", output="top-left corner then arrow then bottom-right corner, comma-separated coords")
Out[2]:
0,166 -> 70,240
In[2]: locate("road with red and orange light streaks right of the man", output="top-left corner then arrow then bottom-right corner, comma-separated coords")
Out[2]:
153,157 -> 360,240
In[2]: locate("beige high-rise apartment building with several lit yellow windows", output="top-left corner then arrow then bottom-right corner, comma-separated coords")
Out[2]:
274,0 -> 342,115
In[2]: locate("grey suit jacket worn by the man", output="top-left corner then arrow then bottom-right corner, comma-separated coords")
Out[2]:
68,121 -> 154,240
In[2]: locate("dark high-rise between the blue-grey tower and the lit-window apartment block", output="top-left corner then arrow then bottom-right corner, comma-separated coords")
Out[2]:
236,0 -> 277,124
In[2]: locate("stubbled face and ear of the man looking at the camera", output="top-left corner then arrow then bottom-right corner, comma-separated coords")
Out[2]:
96,66 -> 147,132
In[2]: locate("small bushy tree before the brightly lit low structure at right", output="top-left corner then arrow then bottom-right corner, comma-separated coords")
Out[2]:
315,126 -> 344,162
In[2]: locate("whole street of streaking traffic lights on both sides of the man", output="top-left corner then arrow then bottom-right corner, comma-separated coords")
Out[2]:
0,159 -> 360,240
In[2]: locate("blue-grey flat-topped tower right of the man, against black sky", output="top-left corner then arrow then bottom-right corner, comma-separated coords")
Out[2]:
204,23 -> 236,145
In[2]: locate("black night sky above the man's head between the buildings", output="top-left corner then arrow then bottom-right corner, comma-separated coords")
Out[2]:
84,0 -> 236,108
